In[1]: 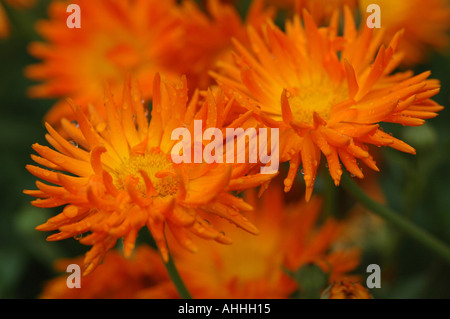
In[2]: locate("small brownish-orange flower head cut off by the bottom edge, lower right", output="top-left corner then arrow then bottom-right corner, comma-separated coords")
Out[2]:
322,278 -> 372,299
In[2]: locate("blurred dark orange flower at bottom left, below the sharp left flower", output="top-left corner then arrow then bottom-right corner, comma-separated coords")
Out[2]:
39,246 -> 177,299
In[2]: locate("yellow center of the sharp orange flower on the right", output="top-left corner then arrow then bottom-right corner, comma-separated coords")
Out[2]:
287,84 -> 348,125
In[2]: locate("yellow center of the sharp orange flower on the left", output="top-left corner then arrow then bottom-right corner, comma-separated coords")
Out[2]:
112,152 -> 178,197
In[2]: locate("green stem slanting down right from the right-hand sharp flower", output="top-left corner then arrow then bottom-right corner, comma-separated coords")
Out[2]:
342,173 -> 450,263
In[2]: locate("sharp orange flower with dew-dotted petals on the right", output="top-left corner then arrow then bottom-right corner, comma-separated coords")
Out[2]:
213,9 -> 443,199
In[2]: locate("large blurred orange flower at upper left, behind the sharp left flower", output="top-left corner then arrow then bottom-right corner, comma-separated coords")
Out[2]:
25,0 -> 183,124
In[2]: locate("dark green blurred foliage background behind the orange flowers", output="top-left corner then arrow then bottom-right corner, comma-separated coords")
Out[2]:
0,0 -> 450,298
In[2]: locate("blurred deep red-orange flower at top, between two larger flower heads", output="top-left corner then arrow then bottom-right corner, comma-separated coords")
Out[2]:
173,0 -> 274,89
